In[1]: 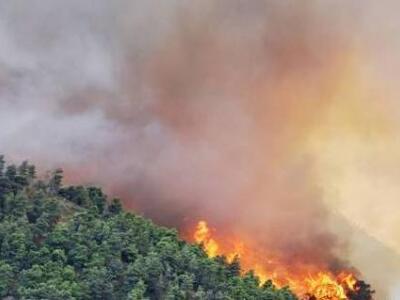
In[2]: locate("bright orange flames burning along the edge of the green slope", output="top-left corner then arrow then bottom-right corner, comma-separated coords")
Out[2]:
193,221 -> 358,300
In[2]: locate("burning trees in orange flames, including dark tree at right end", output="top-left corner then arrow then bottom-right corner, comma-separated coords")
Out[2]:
193,221 -> 374,300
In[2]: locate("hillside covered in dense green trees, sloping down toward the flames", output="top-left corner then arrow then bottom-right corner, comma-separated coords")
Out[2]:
0,157 -> 296,300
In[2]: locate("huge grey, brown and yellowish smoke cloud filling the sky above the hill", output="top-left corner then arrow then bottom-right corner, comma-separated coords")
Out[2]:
0,0 -> 400,296
